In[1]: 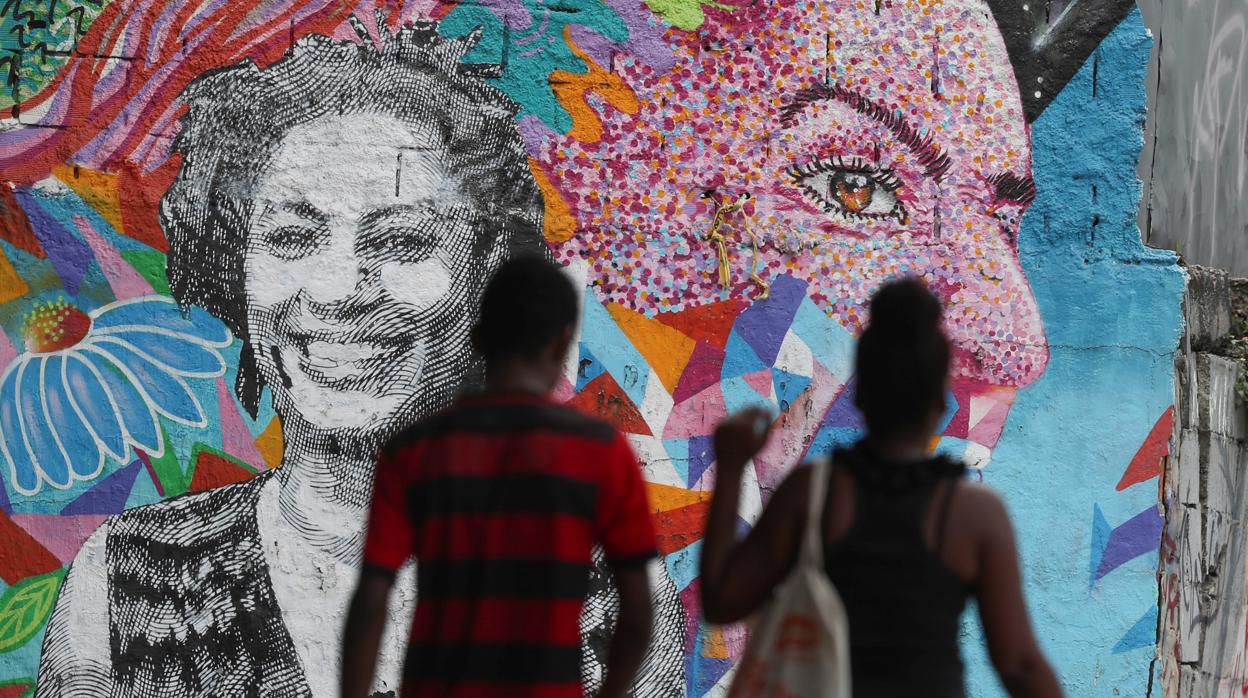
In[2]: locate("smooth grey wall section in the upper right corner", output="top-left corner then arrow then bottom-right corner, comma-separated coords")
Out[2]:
1139,0 -> 1248,276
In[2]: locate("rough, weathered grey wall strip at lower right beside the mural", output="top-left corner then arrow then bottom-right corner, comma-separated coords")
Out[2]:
1157,267 -> 1248,697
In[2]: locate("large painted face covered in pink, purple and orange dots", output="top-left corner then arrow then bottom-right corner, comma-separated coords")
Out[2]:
540,0 -> 1047,442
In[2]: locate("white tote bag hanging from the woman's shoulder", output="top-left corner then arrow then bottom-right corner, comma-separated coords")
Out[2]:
728,458 -> 850,698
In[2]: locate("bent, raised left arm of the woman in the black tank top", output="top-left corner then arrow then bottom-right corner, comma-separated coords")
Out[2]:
700,410 -> 810,623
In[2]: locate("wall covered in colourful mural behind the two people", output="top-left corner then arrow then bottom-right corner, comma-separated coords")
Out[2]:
0,0 -> 1183,696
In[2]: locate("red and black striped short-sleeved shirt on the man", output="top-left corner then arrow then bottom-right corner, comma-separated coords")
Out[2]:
364,395 -> 656,698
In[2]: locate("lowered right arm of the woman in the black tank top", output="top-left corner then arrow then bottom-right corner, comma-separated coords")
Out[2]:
966,487 -> 1062,698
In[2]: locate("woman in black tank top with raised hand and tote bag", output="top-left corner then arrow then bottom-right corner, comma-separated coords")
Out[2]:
701,280 -> 1062,698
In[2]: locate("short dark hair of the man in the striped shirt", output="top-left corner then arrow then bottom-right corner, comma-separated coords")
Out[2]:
477,255 -> 579,365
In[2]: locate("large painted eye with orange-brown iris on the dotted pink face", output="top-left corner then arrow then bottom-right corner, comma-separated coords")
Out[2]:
789,157 -> 906,224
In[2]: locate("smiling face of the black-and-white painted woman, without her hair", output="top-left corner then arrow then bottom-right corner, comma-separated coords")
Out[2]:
246,114 -> 475,431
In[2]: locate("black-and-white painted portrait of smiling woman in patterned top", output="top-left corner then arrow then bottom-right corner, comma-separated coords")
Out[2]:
31,22 -> 684,697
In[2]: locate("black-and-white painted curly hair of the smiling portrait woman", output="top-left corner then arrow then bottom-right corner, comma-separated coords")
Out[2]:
160,21 -> 545,412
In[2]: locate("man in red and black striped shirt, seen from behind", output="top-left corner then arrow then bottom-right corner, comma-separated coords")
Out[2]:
342,257 -> 656,698
